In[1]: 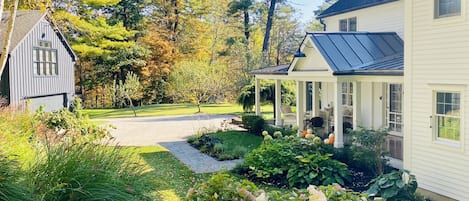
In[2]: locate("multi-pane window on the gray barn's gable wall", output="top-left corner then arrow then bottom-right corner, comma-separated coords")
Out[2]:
33,41 -> 59,76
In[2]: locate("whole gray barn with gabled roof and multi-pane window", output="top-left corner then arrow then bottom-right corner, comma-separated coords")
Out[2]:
0,10 -> 76,111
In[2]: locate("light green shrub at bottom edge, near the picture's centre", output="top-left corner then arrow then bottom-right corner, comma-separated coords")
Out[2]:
185,173 -> 259,201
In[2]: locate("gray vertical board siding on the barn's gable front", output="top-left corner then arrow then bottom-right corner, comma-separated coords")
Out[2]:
9,17 -> 75,109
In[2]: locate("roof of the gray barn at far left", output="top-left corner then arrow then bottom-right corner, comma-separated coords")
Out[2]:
0,10 -> 76,61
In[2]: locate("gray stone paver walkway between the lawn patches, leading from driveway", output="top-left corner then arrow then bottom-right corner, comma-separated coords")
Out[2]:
160,141 -> 242,173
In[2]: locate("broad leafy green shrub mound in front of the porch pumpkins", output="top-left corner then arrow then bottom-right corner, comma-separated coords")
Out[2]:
244,136 -> 349,187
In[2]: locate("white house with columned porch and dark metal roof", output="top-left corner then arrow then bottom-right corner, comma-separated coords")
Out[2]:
253,0 -> 469,200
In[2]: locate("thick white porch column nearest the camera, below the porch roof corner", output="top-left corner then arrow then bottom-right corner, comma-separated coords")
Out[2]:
334,80 -> 344,148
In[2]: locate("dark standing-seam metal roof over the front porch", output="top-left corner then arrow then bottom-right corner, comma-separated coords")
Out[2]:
306,32 -> 404,75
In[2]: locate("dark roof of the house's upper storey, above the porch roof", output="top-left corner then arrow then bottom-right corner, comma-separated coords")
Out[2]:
318,0 -> 398,18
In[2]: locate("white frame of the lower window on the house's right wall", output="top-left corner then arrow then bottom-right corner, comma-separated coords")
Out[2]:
430,84 -> 466,149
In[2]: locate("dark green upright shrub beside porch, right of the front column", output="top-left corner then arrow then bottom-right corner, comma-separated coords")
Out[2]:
351,129 -> 389,176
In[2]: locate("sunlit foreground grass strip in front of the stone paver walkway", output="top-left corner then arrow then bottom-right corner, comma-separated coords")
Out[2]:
136,145 -> 211,201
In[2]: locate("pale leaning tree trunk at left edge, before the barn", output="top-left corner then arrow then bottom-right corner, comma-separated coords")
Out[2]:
0,0 -> 19,78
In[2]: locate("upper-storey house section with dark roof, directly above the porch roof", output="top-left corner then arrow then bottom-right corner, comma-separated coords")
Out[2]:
318,0 -> 404,38
